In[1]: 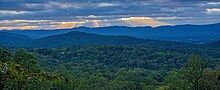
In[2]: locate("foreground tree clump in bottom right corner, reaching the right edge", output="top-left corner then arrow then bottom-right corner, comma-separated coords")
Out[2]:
159,55 -> 219,90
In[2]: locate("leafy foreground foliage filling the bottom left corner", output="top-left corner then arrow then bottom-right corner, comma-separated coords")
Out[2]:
0,49 -> 62,90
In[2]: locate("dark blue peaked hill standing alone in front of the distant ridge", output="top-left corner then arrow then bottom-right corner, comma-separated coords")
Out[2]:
28,31 -> 154,47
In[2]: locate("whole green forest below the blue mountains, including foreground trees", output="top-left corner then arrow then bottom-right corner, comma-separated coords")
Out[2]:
0,45 -> 220,90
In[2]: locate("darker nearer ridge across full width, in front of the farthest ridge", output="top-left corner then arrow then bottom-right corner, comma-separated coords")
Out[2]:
0,28 -> 220,48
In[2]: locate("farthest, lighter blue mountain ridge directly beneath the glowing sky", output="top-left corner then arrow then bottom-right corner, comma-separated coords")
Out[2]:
0,23 -> 220,43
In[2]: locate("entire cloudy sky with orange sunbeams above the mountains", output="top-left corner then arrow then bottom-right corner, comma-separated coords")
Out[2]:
0,0 -> 220,30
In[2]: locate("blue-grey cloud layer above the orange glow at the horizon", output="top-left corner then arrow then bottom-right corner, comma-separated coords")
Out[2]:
0,0 -> 220,23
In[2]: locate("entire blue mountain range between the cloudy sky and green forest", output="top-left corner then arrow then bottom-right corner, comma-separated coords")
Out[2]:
0,24 -> 220,47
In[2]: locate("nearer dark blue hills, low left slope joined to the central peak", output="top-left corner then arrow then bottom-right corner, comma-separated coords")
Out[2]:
0,31 -> 154,47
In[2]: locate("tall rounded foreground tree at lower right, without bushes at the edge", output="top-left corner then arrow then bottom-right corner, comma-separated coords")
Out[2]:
162,55 -> 208,90
